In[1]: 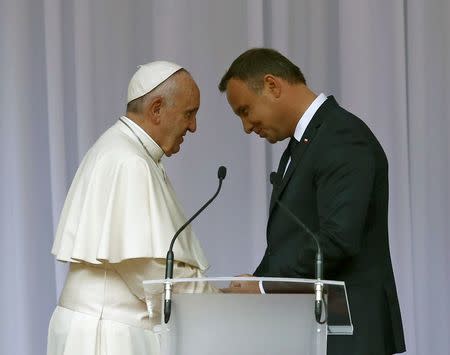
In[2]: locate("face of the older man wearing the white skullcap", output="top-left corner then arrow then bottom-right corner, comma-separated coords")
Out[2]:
161,74 -> 200,156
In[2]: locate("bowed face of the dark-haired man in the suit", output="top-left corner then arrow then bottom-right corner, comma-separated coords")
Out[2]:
227,79 -> 287,143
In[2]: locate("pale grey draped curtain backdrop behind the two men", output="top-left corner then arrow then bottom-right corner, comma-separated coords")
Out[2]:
0,0 -> 450,355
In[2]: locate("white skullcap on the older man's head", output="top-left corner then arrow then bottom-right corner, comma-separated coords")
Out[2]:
127,61 -> 183,103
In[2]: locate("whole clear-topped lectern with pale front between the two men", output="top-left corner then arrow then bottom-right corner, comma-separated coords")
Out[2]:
144,277 -> 353,355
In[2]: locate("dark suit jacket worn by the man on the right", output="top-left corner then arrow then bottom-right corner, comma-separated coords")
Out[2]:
254,96 -> 405,355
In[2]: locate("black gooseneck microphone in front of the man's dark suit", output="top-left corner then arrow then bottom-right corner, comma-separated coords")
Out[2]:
270,171 -> 327,324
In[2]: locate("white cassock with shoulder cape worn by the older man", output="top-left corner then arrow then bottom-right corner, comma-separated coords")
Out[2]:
47,117 -> 213,355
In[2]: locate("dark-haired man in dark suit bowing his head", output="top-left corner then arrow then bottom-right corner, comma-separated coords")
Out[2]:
219,48 -> 405,355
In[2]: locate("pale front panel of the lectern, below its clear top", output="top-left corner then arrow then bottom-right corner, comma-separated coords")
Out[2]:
167,294 -> 326,355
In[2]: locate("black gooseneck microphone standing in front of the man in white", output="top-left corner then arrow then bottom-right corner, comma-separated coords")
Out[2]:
164,166 -> 227,323
